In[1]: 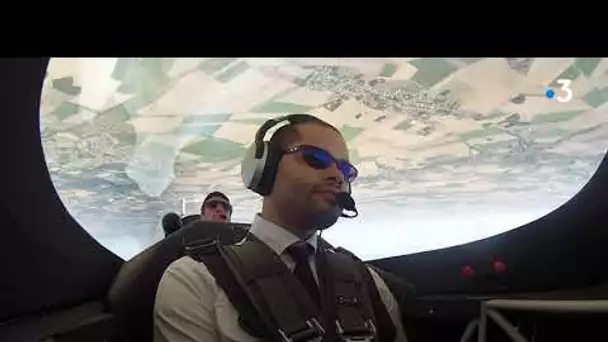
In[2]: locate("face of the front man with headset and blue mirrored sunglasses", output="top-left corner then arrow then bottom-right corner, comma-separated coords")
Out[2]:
271,124 -> 348,216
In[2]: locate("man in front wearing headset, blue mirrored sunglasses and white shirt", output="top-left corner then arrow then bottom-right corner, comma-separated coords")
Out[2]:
154,114 -> 406,342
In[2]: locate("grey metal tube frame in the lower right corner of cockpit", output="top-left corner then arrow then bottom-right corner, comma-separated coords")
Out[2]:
460,299 -> 608,342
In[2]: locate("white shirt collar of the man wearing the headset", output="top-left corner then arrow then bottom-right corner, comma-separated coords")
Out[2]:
249,214 -> 317,255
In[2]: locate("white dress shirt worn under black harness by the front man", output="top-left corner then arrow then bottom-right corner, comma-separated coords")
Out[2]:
154,215 -> 406,342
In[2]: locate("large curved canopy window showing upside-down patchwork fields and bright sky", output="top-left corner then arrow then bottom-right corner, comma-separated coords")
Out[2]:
41,58 -> 608,258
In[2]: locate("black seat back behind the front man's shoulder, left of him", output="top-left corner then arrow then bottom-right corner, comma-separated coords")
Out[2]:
108,220 -> 250,342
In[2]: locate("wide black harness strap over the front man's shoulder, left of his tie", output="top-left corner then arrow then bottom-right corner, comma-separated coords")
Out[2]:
186,235 -> 324,342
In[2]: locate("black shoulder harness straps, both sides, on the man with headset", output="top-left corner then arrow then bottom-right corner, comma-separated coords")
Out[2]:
186,238 -> 394,342
